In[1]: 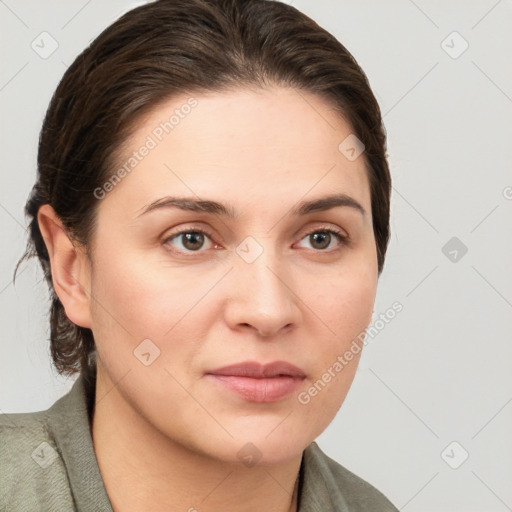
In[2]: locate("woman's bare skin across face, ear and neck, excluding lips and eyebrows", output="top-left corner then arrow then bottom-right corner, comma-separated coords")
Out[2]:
38,87 -> 378,512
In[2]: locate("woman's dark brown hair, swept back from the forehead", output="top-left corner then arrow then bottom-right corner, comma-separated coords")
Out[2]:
15,0 -> 391,379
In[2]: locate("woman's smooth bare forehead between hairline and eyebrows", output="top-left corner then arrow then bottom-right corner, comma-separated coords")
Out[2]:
102,87 -> 370,213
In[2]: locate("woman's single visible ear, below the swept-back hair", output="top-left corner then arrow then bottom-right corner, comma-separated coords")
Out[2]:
37,204 -> 92,328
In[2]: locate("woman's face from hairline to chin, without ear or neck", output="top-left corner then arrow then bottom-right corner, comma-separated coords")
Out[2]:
86,88 -> 378,464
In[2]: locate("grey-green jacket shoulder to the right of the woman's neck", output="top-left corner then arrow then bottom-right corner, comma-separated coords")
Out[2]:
305,442 -> 398,512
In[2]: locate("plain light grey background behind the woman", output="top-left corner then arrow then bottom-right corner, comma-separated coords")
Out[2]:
0,0 -> 512,512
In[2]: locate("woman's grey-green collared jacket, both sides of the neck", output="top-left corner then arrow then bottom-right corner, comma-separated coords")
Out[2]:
0,375 -> 398,512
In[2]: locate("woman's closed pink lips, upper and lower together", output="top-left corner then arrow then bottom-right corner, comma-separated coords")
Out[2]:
207,361 -> 306,403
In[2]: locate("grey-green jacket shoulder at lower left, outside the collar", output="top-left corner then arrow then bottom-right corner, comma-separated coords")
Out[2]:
0,396 -> 74,512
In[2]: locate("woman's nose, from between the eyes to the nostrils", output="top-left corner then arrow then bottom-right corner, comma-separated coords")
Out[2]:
225,241 -> 301,337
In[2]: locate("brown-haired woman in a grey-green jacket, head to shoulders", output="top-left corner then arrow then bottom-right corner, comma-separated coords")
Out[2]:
0,0 -> 396,512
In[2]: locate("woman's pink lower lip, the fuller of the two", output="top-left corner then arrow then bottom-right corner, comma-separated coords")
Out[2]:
208,374 -> 304,403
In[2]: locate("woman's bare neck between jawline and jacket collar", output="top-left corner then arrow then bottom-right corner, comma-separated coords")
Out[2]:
92,366 -> 302,512
